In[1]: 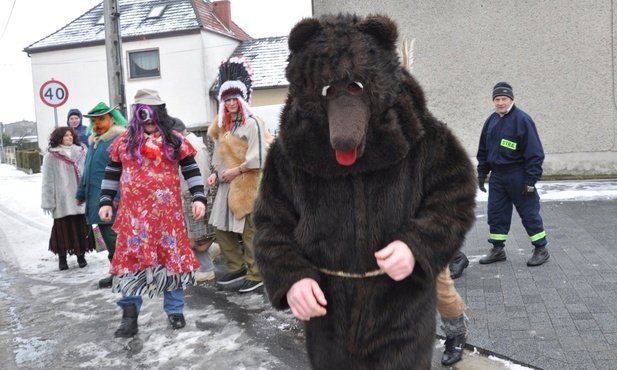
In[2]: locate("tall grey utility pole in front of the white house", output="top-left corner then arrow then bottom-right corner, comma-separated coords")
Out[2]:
103,0 -> 128,117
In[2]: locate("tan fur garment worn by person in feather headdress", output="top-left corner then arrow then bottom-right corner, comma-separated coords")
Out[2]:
208,116 -> 272,220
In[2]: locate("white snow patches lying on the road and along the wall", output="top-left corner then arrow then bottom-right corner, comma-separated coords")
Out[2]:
0,164 -> 617,369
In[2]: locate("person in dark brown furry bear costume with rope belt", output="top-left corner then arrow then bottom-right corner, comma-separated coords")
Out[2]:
253,14 -> 476,370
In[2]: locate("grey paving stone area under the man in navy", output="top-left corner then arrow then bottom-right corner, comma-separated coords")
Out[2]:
448,200 -> 617,370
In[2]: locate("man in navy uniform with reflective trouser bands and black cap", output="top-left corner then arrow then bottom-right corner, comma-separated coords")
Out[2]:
477,82 -> 549,266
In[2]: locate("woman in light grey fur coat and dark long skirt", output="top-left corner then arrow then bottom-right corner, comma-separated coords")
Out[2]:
41,127 -> 95,270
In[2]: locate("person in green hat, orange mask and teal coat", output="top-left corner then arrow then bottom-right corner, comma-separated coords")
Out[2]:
76,102 -> 127,288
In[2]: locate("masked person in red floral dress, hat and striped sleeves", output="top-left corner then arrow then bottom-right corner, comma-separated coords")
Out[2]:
99,89 -> 206,337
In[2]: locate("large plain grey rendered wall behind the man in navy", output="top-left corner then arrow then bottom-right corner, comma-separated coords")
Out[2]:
313,0 -> 617,176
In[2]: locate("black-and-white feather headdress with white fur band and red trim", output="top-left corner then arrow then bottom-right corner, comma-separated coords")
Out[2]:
218,56 -> 253,127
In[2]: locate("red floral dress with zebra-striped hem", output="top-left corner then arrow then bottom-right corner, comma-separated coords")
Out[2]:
109,131 -> 199,296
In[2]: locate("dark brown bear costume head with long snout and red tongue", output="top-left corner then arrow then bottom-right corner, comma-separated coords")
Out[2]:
279,14 -> 430,176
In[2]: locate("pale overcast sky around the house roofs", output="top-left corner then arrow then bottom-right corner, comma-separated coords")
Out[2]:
0,0 -> 312,123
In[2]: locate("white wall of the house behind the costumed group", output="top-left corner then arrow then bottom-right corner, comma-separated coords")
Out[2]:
31,32 -> 238,150
